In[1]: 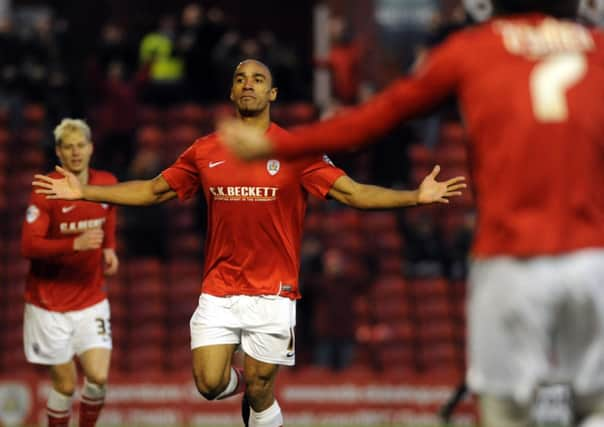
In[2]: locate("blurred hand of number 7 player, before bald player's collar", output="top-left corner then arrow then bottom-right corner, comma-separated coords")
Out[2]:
218,119 -> 272,160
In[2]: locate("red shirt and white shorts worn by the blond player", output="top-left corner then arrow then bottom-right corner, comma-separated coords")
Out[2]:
22,169 -> 117,364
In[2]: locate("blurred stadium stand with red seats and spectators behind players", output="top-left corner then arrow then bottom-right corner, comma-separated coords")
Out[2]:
0,0 -> 482,425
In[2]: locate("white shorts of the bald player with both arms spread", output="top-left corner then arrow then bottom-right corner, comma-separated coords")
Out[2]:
190,294 -> 296,366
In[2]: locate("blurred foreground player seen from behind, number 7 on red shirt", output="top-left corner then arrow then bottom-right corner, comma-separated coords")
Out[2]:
221,0 -> 604,426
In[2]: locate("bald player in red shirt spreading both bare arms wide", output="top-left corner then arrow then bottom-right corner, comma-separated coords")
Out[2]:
34,60 -> 465,427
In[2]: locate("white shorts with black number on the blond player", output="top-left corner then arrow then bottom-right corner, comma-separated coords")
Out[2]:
23,300 -> 111,365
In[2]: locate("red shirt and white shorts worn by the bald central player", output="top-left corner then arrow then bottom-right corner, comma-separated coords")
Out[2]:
162,124 -> 344,364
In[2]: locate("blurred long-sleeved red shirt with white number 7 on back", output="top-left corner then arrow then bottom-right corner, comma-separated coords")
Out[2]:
272,15 -> 604,257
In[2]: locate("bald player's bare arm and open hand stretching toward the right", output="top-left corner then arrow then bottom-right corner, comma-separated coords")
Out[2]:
328,166 -> 466,209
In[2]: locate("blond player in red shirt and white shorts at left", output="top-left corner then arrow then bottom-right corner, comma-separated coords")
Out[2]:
21,119 -> 118,427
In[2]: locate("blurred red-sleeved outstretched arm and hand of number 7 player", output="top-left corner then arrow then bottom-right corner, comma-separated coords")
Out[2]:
220,34 -> 466,159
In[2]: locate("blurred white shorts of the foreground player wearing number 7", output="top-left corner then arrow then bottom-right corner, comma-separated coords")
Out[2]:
467,250 -> 604,403
